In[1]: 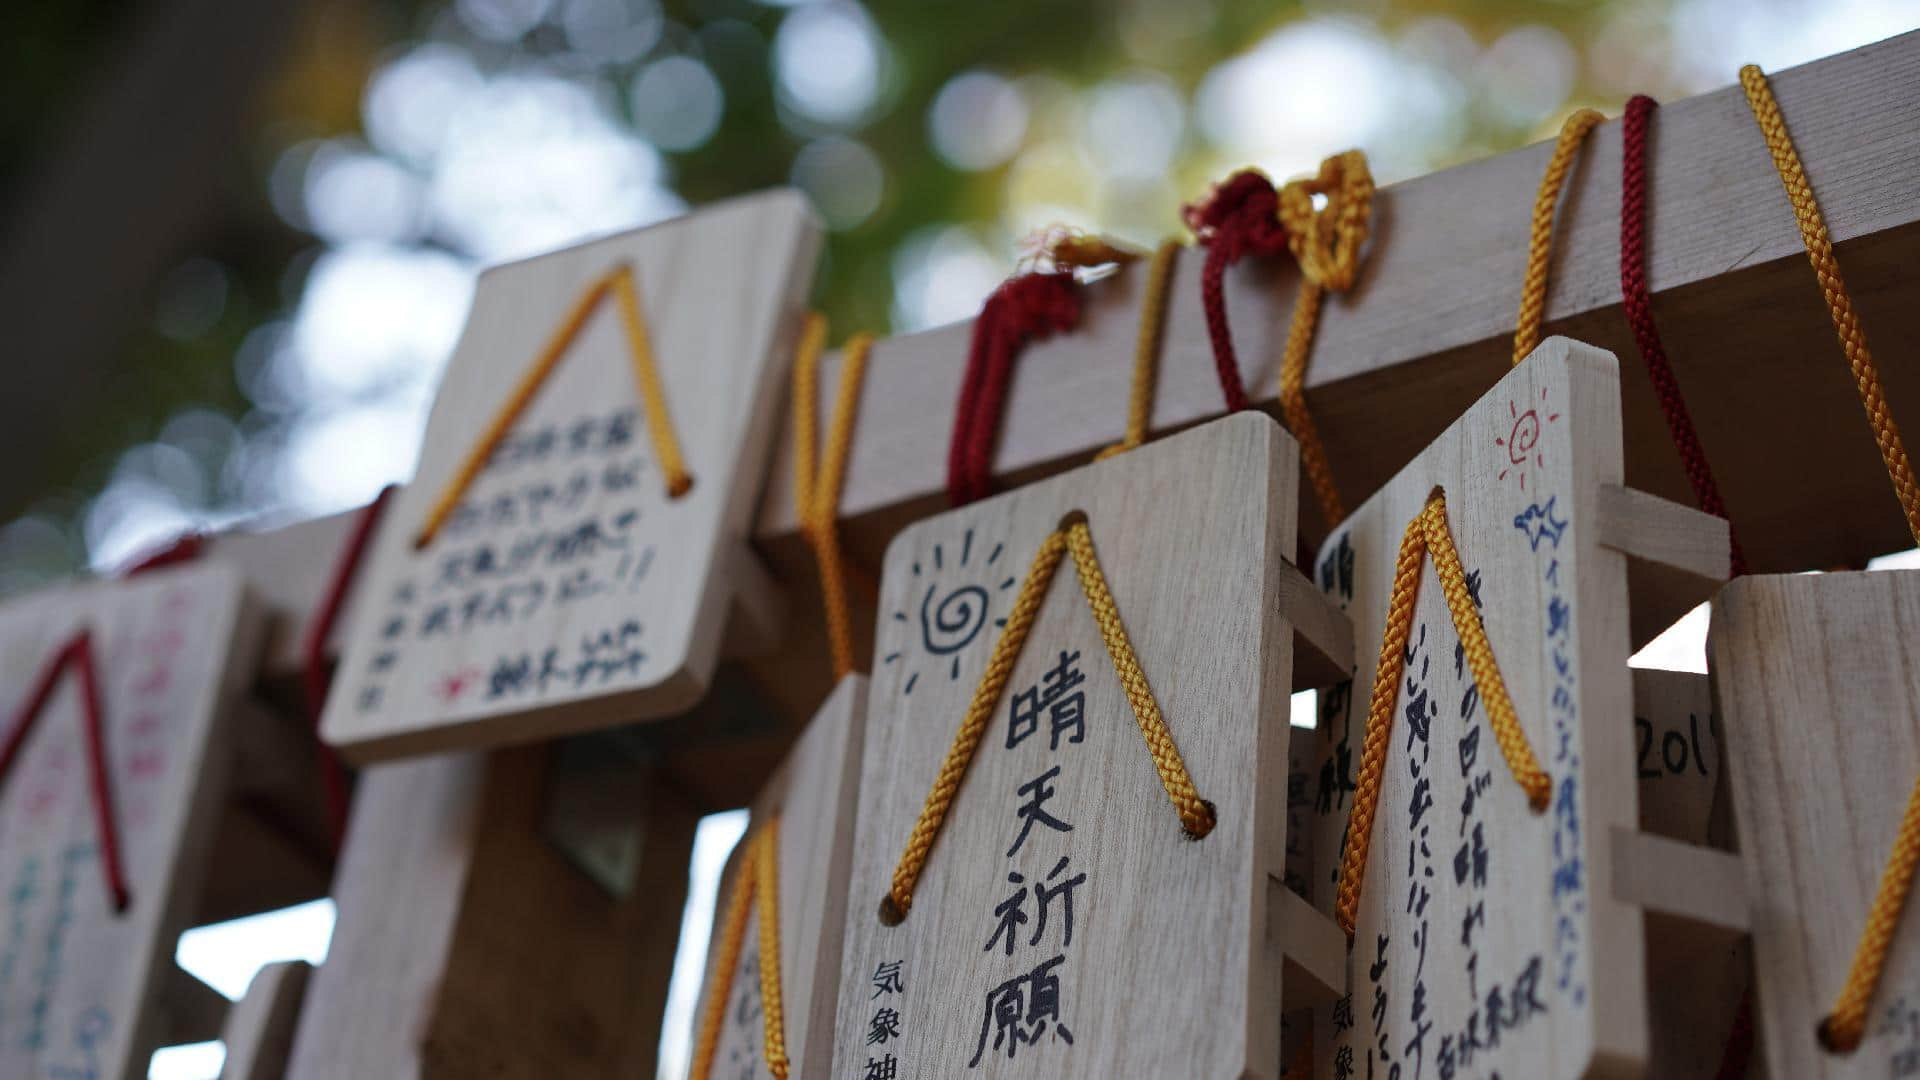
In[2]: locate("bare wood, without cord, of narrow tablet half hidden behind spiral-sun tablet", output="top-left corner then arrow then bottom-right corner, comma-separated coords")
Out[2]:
695,675 -> 866,1080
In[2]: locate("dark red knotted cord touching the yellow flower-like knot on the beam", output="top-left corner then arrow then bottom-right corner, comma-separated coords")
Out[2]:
1181,169 -> 1286,413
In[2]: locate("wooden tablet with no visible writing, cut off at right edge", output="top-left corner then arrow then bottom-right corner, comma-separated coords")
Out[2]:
1707,571 -> 1920,1080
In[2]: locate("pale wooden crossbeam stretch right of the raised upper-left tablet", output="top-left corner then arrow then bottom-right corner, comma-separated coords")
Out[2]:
755,35 -> 1920,595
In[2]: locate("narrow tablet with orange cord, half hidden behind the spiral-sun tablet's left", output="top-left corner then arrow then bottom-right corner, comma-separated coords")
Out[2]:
691,675 -> 866,1080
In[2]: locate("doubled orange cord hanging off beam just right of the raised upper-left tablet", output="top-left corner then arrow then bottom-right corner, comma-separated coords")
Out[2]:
793,313 -> 874,678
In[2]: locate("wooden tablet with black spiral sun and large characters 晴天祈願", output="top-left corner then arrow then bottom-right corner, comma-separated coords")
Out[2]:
833,413 -> 1344,1078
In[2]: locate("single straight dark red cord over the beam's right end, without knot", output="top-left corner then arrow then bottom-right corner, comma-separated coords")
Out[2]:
1620,94 -> 1747,577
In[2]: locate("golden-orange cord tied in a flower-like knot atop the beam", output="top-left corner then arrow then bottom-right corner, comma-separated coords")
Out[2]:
1281,150 -> 1373,527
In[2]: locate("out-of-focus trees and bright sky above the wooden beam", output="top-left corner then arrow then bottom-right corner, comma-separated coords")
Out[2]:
0,0 -> 1920,592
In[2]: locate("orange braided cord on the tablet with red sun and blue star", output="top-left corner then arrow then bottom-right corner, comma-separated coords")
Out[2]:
1334,490 -> 1553,942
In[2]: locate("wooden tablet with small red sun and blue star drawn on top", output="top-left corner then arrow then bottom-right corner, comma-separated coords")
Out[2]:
1313,338 -> 1738,1078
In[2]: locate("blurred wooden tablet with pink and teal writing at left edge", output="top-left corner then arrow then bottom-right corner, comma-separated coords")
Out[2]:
0,567 -> 259,1080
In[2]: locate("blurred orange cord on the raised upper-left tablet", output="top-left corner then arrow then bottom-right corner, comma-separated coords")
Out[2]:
413,265 -> 693,548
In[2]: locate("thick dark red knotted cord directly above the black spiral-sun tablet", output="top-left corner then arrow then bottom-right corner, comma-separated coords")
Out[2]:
947,269 -> 1081,505
